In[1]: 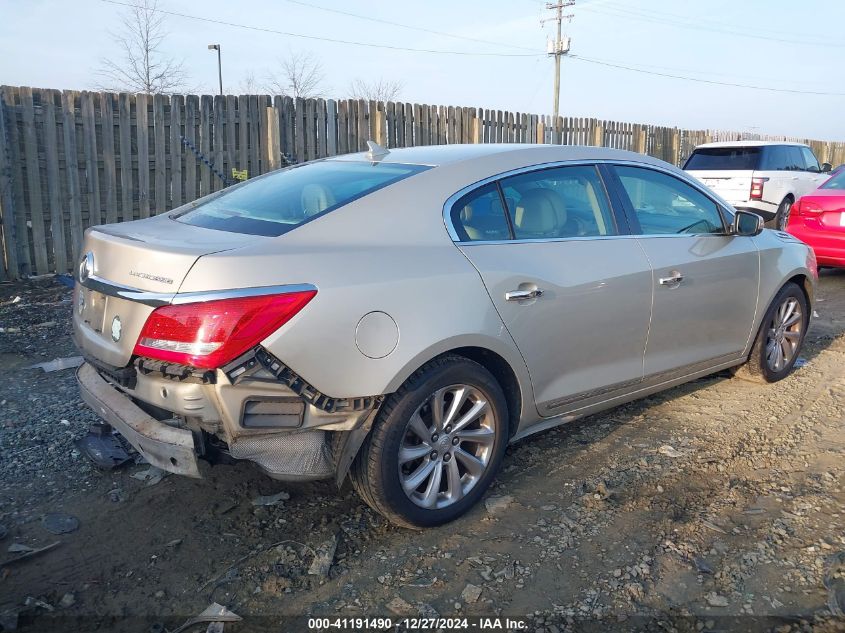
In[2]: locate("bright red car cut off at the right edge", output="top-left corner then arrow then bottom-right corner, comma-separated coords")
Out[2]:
786,169 -> 845,268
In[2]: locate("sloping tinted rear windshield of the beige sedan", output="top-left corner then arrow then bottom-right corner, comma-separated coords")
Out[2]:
175,161 -> 429,237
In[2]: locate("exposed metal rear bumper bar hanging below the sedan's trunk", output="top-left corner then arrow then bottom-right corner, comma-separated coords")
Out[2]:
76,363 -> 201,478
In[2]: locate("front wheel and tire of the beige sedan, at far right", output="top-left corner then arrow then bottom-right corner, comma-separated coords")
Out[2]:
733,282 -> 810,383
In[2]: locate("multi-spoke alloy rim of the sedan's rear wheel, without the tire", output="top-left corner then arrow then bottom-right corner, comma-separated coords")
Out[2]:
399,384 -> 498,509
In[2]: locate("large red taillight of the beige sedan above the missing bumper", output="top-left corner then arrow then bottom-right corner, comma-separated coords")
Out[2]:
134,290 -> 317,369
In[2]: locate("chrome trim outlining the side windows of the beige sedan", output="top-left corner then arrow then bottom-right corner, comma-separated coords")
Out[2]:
443,158 -> 730,246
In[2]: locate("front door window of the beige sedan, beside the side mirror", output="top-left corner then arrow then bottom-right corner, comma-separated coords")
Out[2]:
613,165 -> 725,235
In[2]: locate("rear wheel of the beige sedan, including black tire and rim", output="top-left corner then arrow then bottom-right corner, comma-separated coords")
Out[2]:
350,355 -> 509,528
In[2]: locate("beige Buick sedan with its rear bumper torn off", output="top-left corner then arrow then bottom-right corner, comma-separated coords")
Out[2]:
73,144 -> 816,527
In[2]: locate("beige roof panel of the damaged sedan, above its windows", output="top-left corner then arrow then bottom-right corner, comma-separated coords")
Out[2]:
328,143 -> 667,167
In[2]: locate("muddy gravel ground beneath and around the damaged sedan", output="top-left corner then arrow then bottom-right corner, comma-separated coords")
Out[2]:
0,271 -> 845,633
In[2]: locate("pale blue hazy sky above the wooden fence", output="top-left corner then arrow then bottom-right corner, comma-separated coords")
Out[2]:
0,0 -> 845,140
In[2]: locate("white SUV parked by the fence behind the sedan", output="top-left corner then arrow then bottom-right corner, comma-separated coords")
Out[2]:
684,141 -> 830,230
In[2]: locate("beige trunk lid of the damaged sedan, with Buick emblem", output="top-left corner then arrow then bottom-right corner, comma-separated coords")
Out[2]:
73,215 -> 267,367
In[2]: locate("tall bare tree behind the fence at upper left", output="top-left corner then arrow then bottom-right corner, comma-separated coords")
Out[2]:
99,0 -> 187,93
